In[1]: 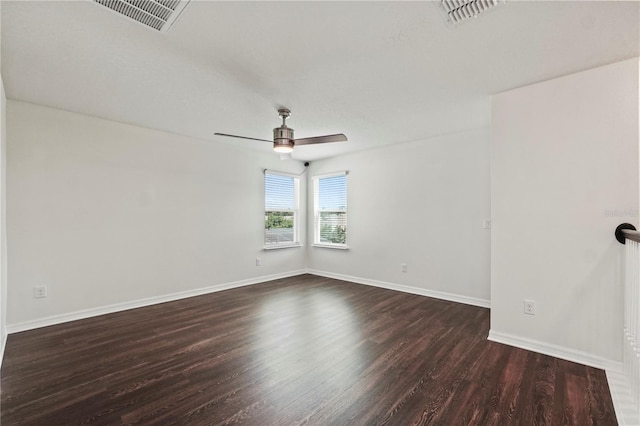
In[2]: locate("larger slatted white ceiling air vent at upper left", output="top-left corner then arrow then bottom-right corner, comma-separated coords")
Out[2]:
94,0 -> 190,32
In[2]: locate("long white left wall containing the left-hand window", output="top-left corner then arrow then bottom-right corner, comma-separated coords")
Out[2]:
7,100 -> 306,329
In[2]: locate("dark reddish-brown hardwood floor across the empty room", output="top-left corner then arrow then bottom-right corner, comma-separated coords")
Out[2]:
0,275 -> 616,426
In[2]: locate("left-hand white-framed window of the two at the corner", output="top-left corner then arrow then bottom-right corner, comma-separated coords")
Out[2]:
264,171 -> 300,248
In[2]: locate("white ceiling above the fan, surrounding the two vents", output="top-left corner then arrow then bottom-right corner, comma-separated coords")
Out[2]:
1,0 -> 640,160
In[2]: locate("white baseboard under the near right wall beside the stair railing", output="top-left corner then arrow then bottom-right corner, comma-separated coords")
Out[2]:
487,330 -> 619,370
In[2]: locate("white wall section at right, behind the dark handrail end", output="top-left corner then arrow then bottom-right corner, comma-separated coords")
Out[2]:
491,59 -> 638,365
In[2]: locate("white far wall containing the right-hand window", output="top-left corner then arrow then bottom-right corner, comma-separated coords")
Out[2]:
307,129 -> 490,305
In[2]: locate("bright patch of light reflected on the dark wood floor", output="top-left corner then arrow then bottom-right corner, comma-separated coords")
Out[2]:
253,289 -> 366,405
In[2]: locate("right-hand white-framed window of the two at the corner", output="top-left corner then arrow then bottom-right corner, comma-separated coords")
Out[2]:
313,172 -> 347,248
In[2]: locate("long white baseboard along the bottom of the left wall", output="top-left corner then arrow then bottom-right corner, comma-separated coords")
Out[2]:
2,269 -> 307,334
